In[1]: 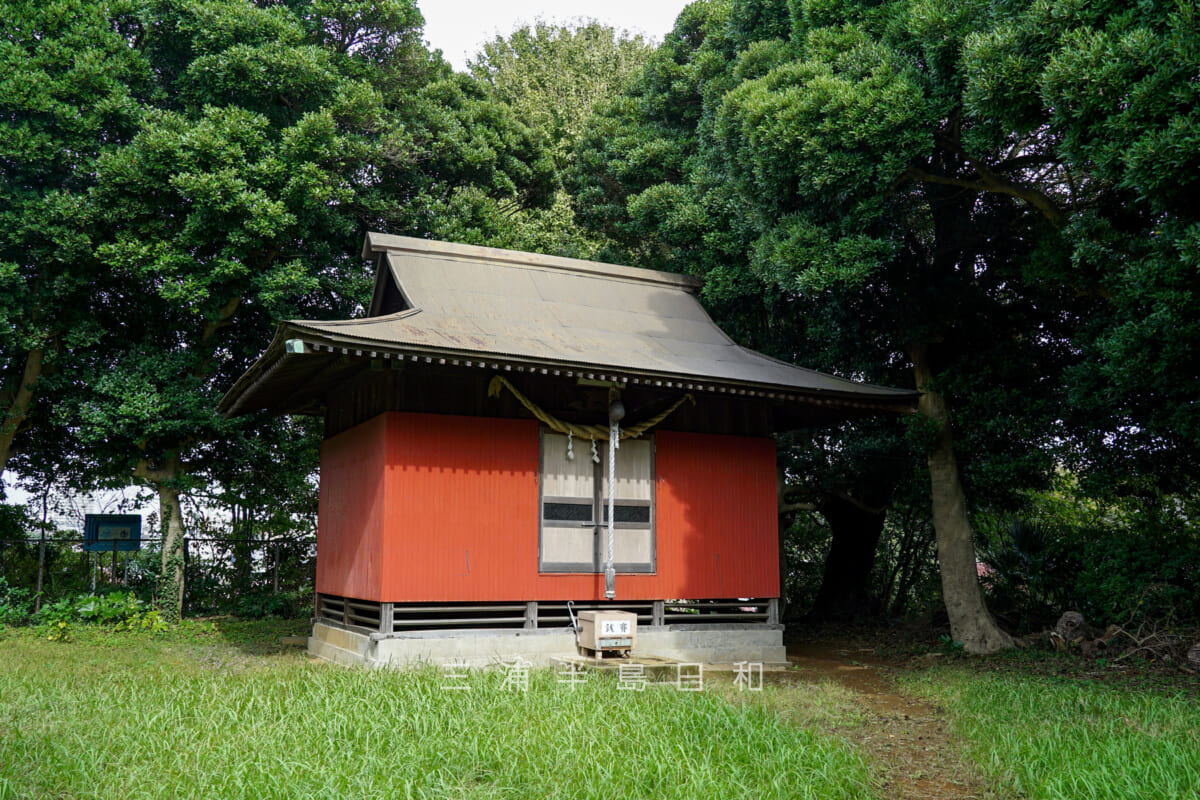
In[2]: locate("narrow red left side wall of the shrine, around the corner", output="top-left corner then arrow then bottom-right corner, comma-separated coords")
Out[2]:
317,416 -> 386,601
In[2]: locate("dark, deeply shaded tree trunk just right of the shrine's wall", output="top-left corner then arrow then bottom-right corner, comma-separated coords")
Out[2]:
811,494 -> 887,620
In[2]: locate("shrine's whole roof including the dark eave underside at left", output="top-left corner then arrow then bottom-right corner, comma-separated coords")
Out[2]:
221,234 -> 918,414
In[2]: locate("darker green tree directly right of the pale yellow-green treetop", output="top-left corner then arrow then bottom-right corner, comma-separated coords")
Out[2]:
565,2 -> 729,272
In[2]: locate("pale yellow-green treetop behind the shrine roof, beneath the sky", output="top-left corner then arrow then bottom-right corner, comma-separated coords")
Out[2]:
403,22 -> 649,258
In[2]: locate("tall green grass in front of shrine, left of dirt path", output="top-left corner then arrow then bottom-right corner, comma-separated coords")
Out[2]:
0,637 -> 870,800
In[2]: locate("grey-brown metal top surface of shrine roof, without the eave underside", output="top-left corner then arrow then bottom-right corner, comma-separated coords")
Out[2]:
290,234 -> 912,396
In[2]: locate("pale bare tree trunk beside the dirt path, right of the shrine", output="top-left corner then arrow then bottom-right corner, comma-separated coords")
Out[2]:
910,344 -> 1015,652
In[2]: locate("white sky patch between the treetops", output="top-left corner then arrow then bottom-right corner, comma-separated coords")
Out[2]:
416,0 -> 689,72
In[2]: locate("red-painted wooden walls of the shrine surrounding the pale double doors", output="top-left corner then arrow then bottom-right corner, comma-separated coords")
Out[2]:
318,413 -> 779,602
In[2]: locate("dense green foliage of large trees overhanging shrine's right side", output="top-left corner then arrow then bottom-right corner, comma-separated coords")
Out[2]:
570,0 -> 1200,638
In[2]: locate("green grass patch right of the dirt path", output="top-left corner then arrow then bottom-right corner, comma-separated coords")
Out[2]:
905,669 -> 1200,800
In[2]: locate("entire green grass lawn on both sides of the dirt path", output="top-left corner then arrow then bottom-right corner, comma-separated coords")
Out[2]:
0,620 -> 1200,800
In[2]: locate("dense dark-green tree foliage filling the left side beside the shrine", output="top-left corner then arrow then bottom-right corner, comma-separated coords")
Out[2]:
0,0 -> 553,612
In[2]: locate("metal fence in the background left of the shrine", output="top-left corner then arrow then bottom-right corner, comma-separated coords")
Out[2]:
0,537 -> 317,616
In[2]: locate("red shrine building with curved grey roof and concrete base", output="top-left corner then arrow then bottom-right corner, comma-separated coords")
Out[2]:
221,234 -> 917,664
